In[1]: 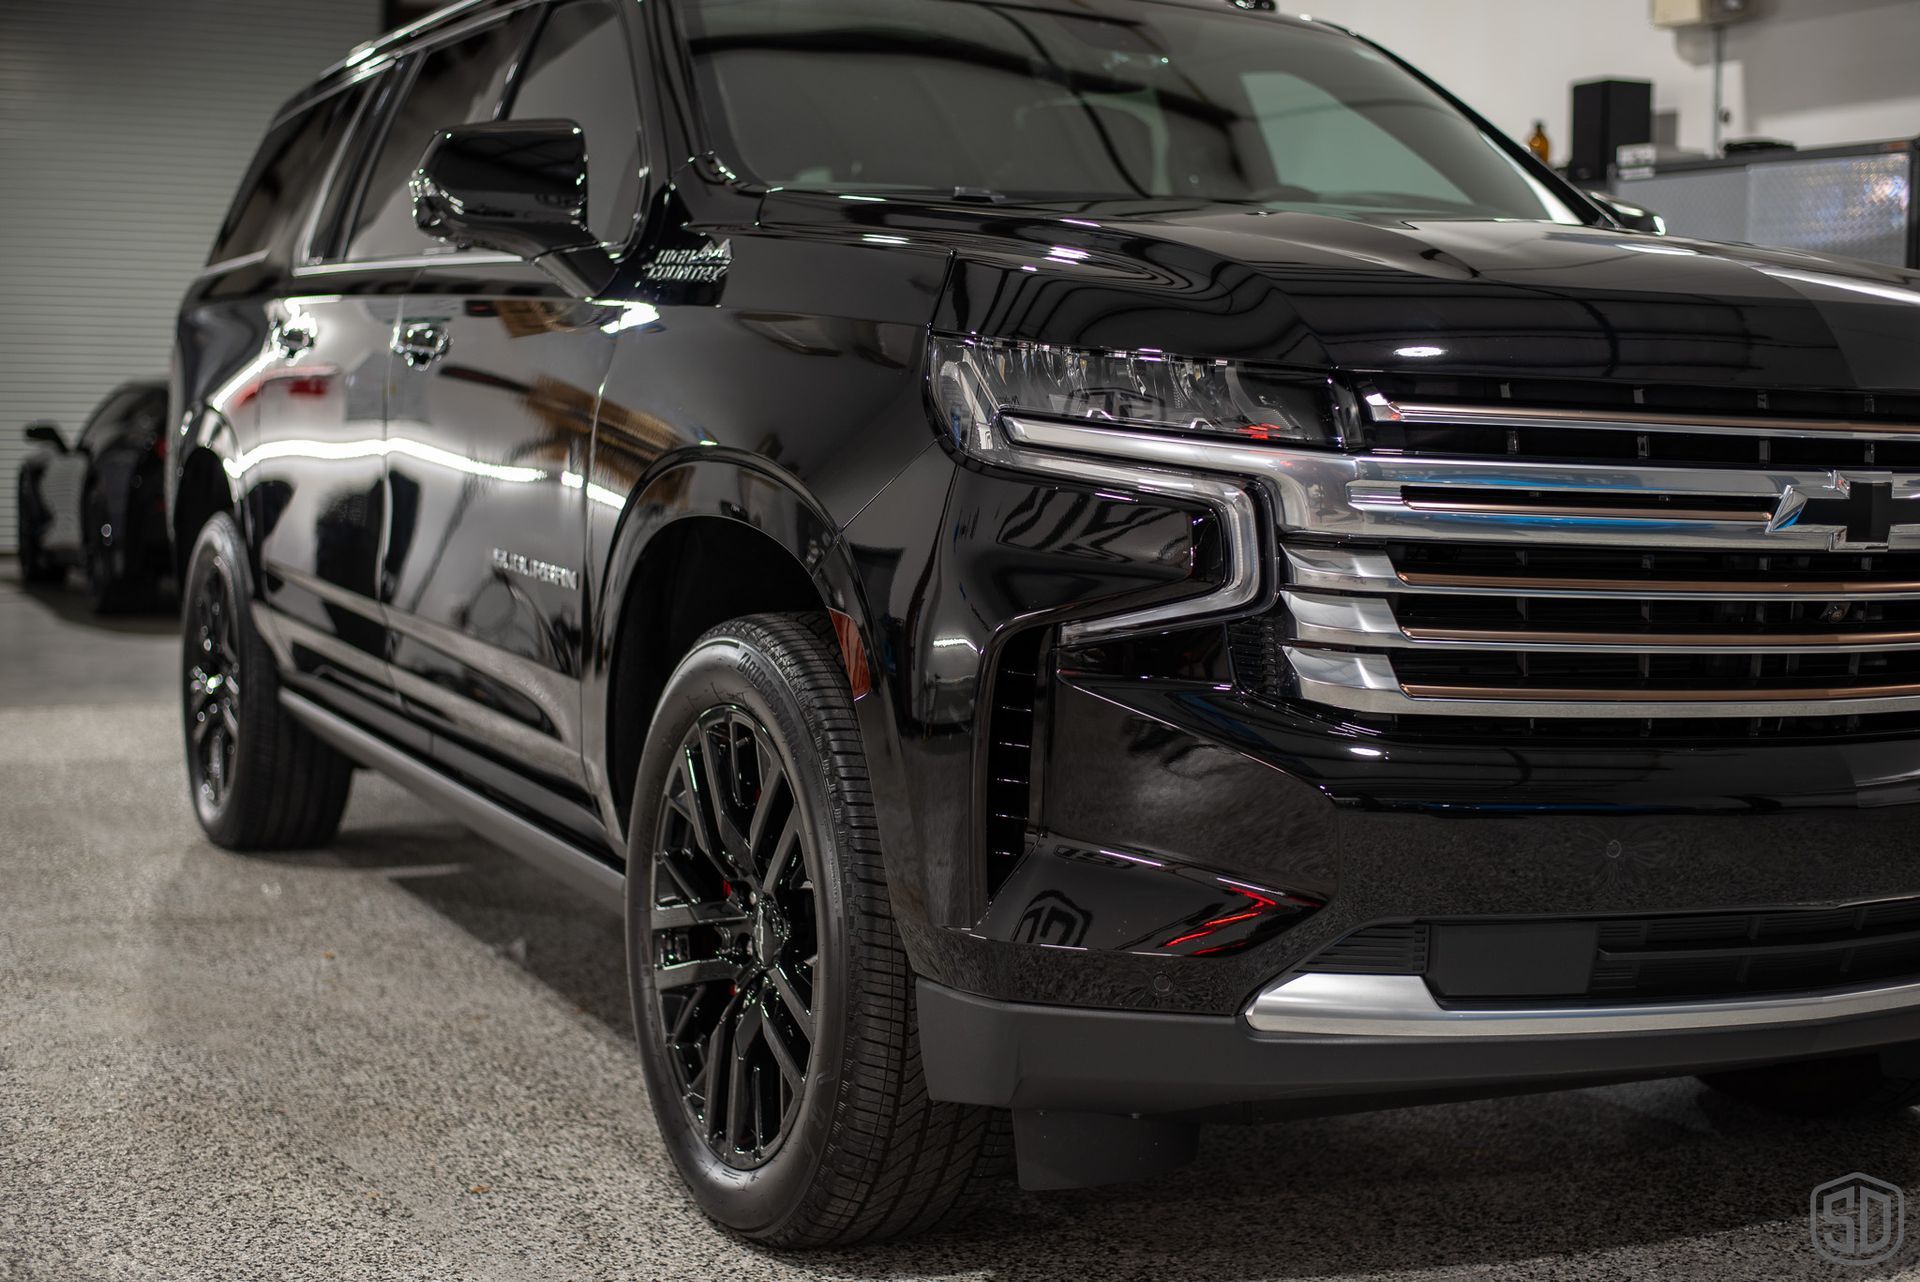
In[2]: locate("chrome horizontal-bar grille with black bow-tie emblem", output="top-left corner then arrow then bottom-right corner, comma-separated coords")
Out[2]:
1267,393 -> 1920,727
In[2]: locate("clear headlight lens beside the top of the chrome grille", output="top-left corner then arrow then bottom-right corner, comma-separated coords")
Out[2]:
929,336 -> 1338,457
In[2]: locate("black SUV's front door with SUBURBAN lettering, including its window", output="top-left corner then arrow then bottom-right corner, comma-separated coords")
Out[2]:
386,0 -> 641,835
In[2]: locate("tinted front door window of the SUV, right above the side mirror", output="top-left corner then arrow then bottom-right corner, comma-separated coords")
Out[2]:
507,0 -> 639,242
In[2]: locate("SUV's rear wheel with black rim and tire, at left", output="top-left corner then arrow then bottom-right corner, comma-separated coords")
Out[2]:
180,512 -> 353,850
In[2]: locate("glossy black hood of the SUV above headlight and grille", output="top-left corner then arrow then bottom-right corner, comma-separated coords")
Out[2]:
766,196 -> 1920,392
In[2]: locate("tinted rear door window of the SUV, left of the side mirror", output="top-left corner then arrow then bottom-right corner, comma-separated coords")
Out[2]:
346,12 -> 534,261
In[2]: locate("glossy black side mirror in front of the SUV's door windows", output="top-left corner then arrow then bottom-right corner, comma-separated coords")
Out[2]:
413,121 -> 599,259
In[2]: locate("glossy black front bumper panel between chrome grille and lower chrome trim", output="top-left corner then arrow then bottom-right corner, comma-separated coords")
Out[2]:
908,670 -> 1920,1017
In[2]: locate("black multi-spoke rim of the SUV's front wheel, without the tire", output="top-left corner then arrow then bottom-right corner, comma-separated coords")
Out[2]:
649,706 -> 822,1171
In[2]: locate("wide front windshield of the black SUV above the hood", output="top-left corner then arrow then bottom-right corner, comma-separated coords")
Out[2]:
684,0 -> 1584,223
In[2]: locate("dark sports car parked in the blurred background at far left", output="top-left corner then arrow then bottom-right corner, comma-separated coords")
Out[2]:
15,378 -> 171,610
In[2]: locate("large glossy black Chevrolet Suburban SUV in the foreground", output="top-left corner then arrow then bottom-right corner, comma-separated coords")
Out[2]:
169,0 -> 1920,1244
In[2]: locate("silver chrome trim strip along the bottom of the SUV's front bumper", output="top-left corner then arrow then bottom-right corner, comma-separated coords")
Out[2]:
1246,973 -> 1920,1038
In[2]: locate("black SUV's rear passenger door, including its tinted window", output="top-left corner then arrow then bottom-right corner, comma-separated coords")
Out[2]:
244,10 -> 534,704
